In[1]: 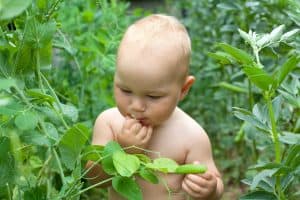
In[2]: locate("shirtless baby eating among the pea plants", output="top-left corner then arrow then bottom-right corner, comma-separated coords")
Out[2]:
87,14 -> 223,200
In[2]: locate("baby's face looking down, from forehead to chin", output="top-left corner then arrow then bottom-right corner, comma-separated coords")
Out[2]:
114,47 -> 182,126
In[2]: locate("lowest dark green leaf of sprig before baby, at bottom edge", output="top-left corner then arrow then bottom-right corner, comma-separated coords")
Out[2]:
112,176 -> 143,200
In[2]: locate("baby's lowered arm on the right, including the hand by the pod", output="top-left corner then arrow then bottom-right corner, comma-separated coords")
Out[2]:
182,129 -> 223,200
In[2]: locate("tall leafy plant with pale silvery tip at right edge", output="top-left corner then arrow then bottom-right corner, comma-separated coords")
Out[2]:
211,25 -> 300,200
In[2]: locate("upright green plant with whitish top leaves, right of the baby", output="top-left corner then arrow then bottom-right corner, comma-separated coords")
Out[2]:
214,25 -> 300,199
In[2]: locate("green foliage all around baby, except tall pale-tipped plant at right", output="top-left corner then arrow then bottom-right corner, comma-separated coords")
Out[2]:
0,0 -> 300,199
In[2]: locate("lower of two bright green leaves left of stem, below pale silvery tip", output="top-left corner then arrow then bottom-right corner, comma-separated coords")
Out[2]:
243,66 -> 273,91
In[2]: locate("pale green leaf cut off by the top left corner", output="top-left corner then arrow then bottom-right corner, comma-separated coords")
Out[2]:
0,0 -> 31,21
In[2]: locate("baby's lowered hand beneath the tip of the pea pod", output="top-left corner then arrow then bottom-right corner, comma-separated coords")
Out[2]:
182,168 -> 218,200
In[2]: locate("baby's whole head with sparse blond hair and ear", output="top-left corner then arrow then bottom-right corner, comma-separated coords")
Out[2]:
114,14 -> 194,125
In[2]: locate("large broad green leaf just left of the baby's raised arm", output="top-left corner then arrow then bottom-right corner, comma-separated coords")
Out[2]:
58,124 -> 90,170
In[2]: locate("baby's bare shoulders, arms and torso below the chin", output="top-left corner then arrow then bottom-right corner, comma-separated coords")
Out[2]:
88,108 -> 223,200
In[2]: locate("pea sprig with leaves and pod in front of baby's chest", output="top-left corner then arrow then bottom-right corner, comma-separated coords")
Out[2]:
82,141 -> 206,200
